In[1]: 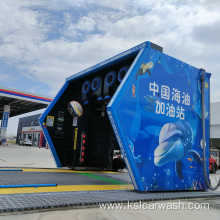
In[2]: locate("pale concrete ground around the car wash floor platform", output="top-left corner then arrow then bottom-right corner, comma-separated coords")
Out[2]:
0,144 -> 220,220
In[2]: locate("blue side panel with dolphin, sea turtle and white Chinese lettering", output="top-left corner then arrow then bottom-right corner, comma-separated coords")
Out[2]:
108,45 -> 210,191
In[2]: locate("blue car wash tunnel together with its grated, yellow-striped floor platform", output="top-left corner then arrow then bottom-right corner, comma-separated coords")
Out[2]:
0,42 -> 220,211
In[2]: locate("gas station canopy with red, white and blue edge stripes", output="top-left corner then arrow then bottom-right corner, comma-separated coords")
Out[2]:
0,87 -> 52,119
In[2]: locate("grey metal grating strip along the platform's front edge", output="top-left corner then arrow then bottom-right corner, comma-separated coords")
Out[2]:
0,190 -> 220,212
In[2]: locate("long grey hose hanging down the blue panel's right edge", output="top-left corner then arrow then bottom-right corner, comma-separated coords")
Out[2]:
201,69 -> 220,190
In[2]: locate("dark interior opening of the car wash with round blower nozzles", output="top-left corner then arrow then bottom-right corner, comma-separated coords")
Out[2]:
41,52 -> 137,170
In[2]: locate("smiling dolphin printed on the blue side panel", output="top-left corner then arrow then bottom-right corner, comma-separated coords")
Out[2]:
154,121 -> 201,179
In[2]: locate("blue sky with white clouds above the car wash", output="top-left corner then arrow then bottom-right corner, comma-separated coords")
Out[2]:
0,0 -> 220,135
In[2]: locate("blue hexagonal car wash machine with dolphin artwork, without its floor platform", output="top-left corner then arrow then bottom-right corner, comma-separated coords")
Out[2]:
40,42 -> 218,191
